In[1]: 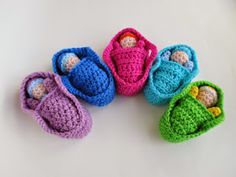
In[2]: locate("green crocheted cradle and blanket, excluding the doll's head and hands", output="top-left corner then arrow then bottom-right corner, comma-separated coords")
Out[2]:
160,81 -> 224,143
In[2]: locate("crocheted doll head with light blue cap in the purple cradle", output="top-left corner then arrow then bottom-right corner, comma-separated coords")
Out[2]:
27,78 -> 47,100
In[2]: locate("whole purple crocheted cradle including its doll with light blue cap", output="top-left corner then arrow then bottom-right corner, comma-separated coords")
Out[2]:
20,72 -> 92,138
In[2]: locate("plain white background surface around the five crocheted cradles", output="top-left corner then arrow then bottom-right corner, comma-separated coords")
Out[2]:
0,0 -> 236,177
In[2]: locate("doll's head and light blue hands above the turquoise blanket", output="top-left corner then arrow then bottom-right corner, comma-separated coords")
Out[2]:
162,48 -> 193,72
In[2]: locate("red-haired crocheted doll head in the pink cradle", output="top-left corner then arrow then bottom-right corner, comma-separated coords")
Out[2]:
119,32 -> 137,48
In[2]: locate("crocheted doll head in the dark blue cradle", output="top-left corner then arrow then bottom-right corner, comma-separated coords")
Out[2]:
58,53 -> 80,73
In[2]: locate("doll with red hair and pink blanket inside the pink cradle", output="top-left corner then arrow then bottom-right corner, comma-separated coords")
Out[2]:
111,32 -> 147,83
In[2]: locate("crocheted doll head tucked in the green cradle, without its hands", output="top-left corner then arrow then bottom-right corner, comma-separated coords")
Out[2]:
197,86 -> 218,108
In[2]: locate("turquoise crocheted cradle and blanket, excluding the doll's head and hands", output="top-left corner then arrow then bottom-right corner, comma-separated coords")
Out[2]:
144,44 -> 199,105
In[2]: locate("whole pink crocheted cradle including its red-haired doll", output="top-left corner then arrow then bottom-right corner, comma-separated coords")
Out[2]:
103,28 -> 157,96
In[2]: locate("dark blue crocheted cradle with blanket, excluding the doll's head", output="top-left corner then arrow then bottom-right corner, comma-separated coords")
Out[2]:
52,47 -> 115,106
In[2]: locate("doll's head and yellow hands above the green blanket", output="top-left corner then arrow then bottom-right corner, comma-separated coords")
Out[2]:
190,86 -> 221,117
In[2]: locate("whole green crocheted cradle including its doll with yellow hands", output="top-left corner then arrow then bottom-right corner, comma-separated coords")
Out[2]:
160,81 -> 224,143
